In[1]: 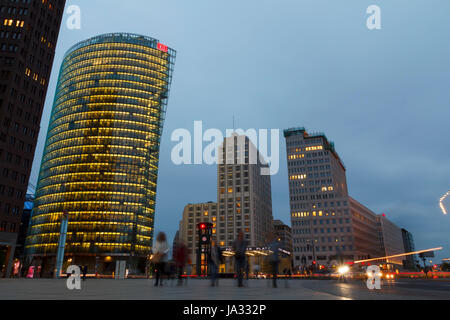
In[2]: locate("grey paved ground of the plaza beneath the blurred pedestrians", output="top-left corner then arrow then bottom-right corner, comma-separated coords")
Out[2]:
0,279 -> 450,300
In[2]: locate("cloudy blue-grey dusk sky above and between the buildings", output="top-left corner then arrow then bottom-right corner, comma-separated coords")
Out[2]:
31,0 -> 450,262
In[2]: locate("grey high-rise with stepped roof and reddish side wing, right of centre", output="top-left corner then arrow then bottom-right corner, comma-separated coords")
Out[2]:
284,128 -> 383,267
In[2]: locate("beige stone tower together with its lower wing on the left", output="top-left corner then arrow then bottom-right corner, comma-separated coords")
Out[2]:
179,134 -> 275,272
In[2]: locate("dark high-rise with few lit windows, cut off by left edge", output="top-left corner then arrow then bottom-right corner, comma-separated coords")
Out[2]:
0,0 -> 65,276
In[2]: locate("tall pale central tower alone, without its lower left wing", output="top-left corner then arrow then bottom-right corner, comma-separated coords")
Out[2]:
217,134 -> 273,247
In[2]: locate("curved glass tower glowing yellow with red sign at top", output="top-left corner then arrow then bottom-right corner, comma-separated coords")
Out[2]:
26,34 -> 176,272
